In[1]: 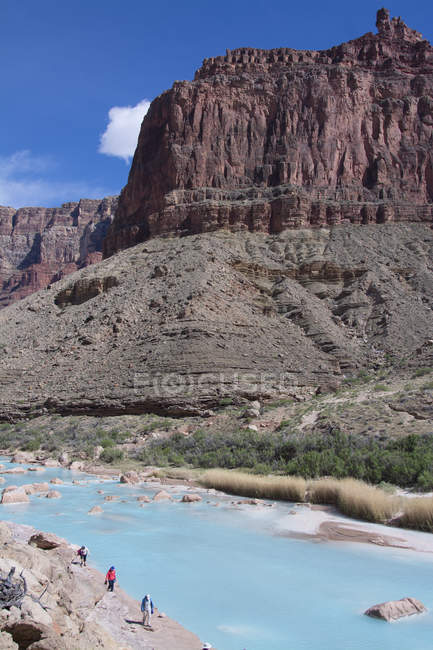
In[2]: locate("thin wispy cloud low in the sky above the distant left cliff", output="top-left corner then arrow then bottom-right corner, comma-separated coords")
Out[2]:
0,151 -> 116,208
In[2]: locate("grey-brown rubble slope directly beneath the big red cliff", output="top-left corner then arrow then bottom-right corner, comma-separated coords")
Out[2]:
0,224 -> 433,419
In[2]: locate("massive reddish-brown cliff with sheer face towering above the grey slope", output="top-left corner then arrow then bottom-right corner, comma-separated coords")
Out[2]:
104,10 -> 433,255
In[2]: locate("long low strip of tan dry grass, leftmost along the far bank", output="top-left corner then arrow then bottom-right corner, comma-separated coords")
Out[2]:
200,469 -> 307,501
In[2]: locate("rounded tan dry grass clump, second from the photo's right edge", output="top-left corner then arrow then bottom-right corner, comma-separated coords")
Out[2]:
336,479 -> 401,523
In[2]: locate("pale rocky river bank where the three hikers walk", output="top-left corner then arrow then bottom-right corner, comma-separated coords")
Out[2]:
0,521 -> 202,650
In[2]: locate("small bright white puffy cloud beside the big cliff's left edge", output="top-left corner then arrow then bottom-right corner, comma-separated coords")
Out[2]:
98,99 -> 150,163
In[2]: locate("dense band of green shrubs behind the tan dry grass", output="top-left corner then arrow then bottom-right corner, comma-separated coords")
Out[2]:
140,429 -> 433,490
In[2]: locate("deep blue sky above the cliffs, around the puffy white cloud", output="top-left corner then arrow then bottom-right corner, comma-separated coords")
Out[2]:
0,0 -> 433,207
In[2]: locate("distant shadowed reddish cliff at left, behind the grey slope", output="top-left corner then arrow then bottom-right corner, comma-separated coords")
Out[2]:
0,197 -> 117,308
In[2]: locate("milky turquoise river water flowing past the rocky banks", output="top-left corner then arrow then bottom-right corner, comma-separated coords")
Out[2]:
0,460 -> 433,650
